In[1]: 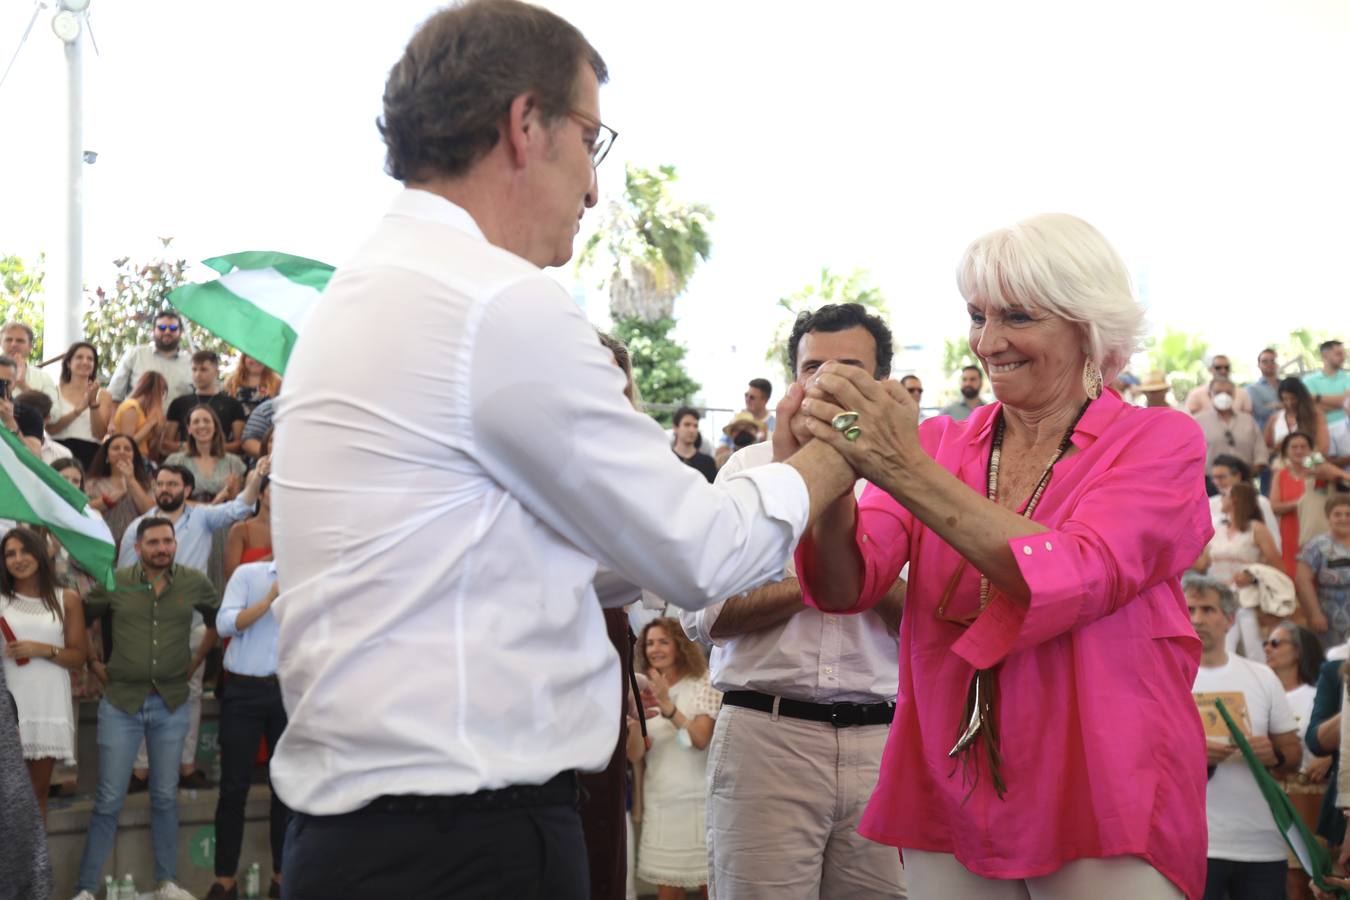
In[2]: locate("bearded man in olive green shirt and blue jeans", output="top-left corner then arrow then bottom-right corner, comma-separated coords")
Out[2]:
77,517 -> 220,900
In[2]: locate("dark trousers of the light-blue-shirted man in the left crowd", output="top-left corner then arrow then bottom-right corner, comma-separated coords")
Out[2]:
216,677 -> 290,878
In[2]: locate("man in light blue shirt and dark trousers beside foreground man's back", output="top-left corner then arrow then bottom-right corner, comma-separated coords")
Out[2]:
207,563 -> 290,900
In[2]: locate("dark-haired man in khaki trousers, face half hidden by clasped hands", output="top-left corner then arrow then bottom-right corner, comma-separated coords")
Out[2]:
680,304 -> 905,900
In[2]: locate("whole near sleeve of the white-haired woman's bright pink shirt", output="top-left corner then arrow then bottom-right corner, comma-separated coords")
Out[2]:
952,414 -> 1214,669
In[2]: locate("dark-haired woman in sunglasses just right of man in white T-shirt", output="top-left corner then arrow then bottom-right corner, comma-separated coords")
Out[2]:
1264,622 -> 1331,900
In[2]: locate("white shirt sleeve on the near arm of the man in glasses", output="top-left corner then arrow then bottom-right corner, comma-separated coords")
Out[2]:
472,282 -> 810,609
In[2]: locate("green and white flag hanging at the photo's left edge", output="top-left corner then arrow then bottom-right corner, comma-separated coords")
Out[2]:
0,428 -> 117,590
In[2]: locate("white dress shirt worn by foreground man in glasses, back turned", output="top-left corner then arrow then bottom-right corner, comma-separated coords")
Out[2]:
271,190 -> 809,815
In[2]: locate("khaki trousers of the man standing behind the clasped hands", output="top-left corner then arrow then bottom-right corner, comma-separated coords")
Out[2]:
707,706 -> 906,900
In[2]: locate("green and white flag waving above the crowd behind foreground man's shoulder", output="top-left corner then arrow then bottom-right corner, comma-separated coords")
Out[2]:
169,251 -> 333,372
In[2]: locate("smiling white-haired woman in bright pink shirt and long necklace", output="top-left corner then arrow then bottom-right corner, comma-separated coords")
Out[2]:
775,215 -> 1212,900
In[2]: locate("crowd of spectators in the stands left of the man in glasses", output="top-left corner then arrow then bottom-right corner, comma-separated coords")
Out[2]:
0,309 -> 286,900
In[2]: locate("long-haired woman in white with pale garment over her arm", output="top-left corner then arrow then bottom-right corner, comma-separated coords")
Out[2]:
1195,483 -> 1284,663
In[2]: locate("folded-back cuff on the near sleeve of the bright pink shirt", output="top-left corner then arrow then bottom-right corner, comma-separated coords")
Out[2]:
952,532 -> 1085,669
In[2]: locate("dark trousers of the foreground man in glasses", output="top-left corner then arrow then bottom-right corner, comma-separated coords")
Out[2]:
281,804 -> 590,900
